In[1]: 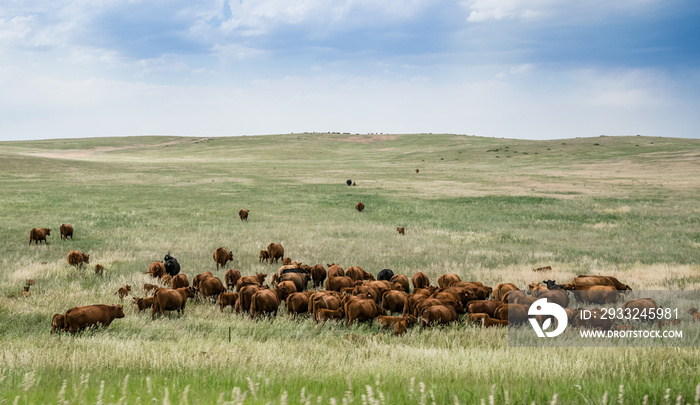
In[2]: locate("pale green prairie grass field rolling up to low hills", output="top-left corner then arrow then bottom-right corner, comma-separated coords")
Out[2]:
0,134 -> 700,404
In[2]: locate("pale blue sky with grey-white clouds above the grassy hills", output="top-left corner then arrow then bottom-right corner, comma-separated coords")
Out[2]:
0,0 -> 700,140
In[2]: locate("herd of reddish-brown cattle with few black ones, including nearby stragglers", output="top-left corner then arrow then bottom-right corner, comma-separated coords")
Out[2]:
25,227 -> 700,335
